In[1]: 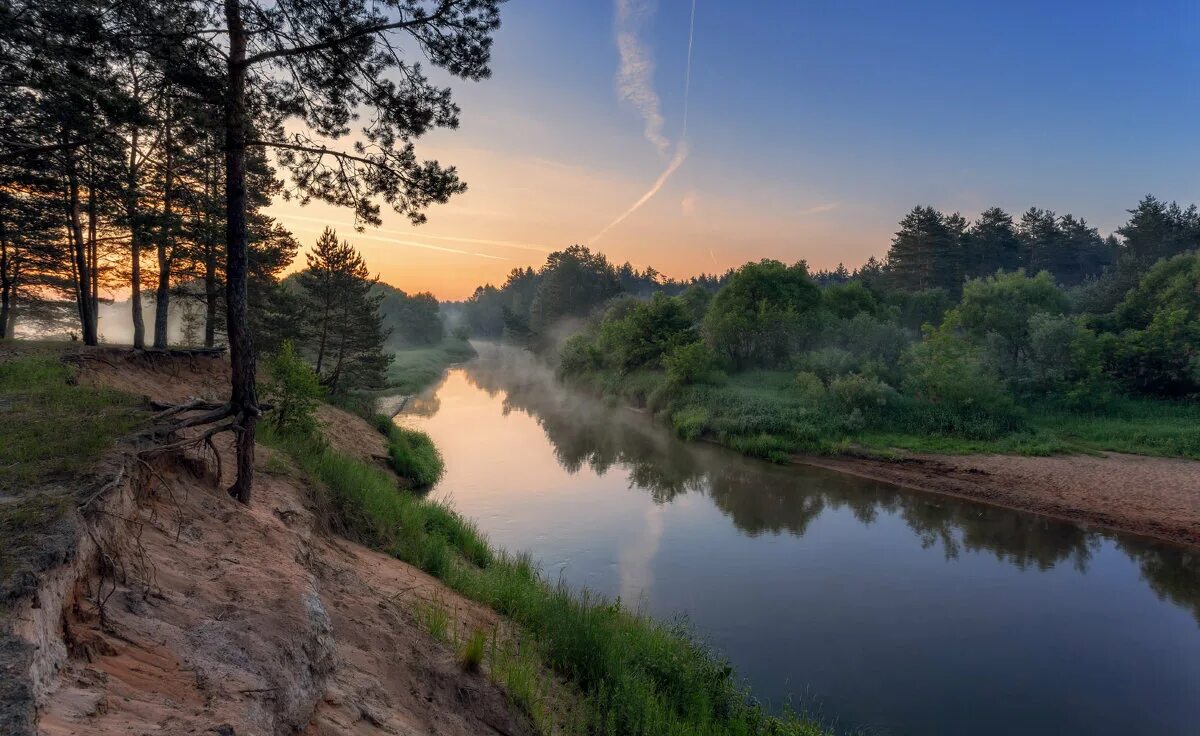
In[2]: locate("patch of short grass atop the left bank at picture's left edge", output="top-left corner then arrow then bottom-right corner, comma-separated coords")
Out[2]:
0,355 -> 143,492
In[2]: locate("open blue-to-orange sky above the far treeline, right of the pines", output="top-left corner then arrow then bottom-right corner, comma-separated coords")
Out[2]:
269,0 -> 1200,299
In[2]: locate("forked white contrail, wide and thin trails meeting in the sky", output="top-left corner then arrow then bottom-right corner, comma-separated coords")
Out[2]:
588,0 -> 696,244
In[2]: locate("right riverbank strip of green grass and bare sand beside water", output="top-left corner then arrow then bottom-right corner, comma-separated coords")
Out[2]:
568,371 -> 1200,546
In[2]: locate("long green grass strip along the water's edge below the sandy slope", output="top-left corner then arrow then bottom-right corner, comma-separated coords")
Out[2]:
259,420 -> 826,736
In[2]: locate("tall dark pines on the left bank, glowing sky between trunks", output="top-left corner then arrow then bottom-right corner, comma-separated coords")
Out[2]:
0,0 -> 500,502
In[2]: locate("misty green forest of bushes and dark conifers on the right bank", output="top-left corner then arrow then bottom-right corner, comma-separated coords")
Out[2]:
461,196 -> 1200,460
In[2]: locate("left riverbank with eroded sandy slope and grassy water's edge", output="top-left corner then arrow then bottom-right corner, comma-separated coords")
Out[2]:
0,349 -> 826,736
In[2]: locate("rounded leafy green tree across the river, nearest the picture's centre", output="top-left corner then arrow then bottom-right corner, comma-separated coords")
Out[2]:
703,261 -> 821,369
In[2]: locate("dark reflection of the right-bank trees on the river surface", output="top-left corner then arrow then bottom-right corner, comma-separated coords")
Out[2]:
466,354 -> 1200,612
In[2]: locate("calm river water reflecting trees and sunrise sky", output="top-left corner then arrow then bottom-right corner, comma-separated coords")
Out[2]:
397,346 -> 1200,736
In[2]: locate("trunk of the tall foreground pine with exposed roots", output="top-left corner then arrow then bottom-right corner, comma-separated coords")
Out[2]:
224,0 -> 259,503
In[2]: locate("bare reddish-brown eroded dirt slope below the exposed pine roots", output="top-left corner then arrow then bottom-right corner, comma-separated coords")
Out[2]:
38,357 -> 530,736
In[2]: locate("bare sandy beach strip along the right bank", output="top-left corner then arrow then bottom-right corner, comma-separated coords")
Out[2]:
796,453 -> 1200,546
